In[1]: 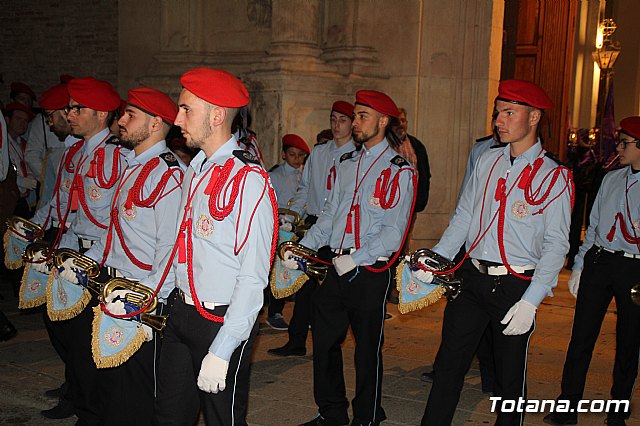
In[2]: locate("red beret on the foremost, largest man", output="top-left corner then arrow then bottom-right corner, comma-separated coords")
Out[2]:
180,68 -> 249,108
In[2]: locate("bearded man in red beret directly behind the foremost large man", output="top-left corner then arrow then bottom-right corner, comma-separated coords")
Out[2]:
85,87 -> 186,425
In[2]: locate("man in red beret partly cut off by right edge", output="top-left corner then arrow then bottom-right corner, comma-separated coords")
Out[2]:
544,117 -> 640,425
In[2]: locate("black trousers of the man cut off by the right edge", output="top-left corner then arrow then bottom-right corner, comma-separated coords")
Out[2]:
560,247 -> 640,418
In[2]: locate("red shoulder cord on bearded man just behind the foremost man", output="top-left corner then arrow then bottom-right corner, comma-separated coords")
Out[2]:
100,157 -> 183,271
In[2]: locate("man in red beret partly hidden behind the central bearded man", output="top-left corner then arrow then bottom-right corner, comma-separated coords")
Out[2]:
267,101 -> 356,356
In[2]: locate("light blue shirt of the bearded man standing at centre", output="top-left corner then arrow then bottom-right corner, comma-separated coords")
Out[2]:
300,139 -> 415,265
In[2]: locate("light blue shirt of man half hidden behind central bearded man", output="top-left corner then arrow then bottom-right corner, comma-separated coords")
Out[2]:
289,140 -> 356,216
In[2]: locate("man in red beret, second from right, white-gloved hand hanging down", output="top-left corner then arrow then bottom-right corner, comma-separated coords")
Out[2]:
414,80 -> 573,426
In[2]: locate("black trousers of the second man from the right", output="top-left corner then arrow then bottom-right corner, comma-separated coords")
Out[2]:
422,260 -> 535,426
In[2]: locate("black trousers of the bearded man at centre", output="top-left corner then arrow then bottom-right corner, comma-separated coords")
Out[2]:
311,262 -> 390,424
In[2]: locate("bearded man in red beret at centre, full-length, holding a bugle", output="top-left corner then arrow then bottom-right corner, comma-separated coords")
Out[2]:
283,90 -> 414,425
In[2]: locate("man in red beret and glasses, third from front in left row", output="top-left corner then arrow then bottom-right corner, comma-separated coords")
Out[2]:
45,77 -> 127,424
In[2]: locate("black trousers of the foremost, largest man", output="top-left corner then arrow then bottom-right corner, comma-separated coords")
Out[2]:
154,298 -> 258,425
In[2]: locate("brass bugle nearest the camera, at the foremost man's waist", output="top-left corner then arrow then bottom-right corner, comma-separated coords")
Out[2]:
102,278 -> 168,331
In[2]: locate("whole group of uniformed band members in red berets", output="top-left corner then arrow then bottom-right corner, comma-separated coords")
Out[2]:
0,68 -> 640,426
